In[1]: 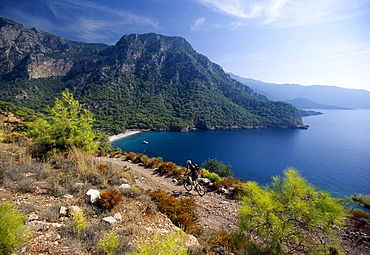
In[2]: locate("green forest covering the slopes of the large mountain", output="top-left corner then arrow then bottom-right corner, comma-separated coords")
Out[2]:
0,34 -> 302,133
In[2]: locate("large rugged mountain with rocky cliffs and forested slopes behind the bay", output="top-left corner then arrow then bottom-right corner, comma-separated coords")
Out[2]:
0,18 -> 305,133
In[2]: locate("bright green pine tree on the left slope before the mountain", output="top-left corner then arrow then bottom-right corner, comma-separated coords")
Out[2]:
28,90 -> 98,157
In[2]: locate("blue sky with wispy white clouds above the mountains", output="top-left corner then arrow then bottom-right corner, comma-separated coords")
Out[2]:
0,0 -> 370,91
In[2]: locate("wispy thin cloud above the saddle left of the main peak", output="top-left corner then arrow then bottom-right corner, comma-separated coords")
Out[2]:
45,0 -> 159,43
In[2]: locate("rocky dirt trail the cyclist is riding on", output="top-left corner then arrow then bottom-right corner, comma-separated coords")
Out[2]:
107,158 -> 239,231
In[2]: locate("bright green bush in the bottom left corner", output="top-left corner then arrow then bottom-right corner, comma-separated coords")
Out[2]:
0,201 -> 29,255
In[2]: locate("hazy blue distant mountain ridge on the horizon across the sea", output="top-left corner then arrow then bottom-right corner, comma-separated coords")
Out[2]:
229,73 -> 370,109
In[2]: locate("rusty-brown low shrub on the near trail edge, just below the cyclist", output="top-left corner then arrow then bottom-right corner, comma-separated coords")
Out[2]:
148,189 -> 201,234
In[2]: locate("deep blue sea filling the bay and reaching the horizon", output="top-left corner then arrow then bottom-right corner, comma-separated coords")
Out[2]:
114,109 -> 370,203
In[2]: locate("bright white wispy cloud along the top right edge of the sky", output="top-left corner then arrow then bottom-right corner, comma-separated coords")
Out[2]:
197,0 -> 370,26
